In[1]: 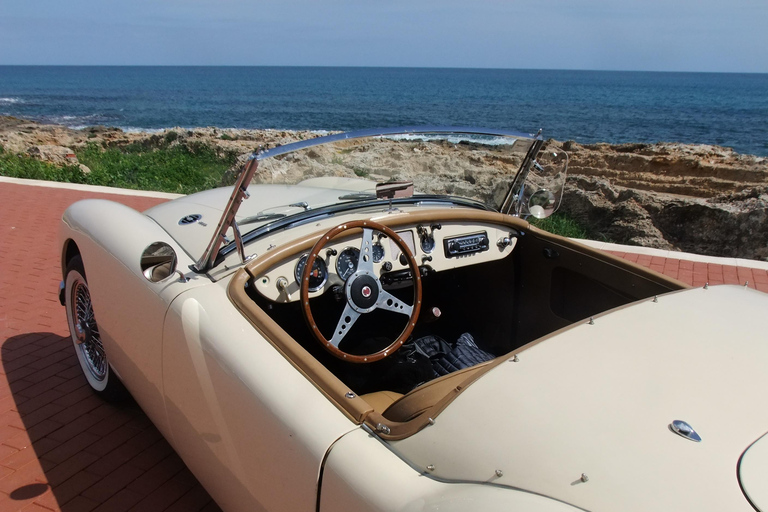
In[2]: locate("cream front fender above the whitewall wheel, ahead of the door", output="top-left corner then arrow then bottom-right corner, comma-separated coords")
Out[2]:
60,199 -> 210,434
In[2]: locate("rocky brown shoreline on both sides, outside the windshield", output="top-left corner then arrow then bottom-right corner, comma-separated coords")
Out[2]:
0,117 -> 768,260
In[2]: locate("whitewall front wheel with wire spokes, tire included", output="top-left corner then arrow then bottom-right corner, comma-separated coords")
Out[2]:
64,255 -> 126,401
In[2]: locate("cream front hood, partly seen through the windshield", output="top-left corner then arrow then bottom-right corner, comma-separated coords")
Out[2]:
144,177 -> 375,260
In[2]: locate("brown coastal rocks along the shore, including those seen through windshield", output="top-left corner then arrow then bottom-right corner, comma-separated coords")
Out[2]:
0,117 -> 768,259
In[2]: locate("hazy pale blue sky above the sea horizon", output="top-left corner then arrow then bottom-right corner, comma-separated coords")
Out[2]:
0,0 -> 768,73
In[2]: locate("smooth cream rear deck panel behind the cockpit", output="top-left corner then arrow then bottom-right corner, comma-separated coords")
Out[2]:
390,286 -> 768,511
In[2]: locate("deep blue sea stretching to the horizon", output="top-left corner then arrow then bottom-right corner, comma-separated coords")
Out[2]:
0,66 -> 768,156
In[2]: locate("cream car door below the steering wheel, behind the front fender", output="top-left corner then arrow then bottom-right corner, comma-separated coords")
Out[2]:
163,283 -> 359,511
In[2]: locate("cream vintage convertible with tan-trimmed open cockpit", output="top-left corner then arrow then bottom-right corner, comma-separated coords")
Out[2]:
61,128 -> 768,511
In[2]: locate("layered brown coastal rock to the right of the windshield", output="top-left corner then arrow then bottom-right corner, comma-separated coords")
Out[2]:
551,141 -> 768,259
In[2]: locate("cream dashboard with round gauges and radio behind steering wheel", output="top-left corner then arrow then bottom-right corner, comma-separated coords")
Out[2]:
249,222 -> 517,302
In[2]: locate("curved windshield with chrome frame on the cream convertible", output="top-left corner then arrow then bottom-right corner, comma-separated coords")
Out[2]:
195,127 -> 548,269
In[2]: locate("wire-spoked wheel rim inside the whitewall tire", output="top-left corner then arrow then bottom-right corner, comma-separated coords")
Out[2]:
72,279 -> 107,381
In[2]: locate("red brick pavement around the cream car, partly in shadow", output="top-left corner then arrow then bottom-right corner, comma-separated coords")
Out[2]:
0,178 -> 768,512
